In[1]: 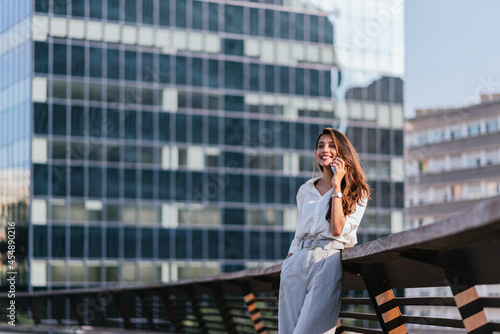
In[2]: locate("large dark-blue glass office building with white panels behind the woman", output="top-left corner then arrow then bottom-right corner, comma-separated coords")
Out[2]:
0,0 -> 403,290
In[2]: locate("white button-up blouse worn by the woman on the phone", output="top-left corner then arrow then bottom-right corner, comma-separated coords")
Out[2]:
288,177 -> 366,253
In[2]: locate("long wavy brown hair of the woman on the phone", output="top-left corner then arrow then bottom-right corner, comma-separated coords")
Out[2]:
315,128 -> 370,221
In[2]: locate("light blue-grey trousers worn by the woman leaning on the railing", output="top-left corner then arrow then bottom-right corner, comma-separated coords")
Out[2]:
278,242 -> 343,334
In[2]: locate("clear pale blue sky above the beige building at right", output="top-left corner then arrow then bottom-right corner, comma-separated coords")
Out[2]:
404,0 -> 500,118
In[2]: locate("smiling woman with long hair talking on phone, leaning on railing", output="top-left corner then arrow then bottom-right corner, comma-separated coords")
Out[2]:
278,128 -> 370,334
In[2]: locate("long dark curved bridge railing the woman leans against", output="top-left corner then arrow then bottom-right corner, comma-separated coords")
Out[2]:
0,197 -> 500,334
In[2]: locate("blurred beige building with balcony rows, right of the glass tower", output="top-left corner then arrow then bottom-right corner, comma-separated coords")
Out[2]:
405,94 -> 500,333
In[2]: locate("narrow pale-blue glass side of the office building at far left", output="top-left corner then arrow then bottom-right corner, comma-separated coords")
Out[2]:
0,0 -> 32,291
